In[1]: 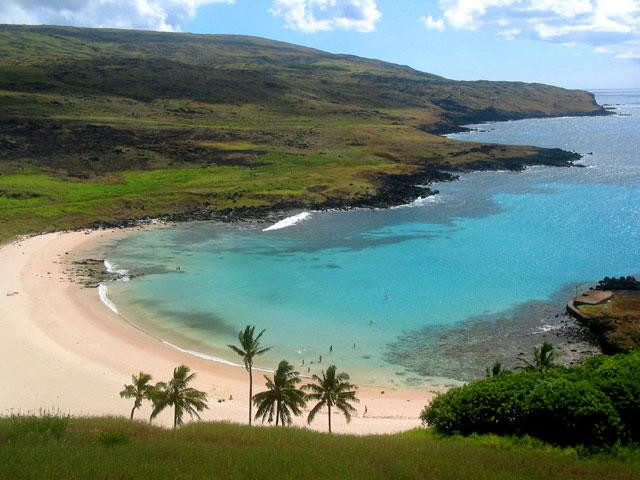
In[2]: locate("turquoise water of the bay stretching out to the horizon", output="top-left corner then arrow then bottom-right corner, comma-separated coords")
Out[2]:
105,91 -> 640,385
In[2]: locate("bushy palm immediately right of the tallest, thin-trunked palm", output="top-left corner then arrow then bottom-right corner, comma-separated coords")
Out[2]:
253,360 -> 306,427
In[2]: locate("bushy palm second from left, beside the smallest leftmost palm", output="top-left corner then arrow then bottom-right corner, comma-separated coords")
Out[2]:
150,365 -> 209,428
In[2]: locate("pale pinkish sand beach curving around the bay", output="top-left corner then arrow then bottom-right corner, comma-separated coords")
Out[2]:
0,230 -> 432,434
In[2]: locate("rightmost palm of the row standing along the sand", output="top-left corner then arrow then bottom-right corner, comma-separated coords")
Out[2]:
302,365 -> 360,433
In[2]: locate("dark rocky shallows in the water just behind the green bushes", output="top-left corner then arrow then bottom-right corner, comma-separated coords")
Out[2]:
385,288 -> 602,382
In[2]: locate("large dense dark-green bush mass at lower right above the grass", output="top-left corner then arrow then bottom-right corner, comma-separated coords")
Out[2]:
421,351 -> 640,446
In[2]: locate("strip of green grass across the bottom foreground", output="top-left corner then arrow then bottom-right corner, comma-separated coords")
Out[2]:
0,417 -> 640,480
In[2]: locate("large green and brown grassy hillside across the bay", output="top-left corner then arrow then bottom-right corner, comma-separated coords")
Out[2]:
0,25 -> 605,240
